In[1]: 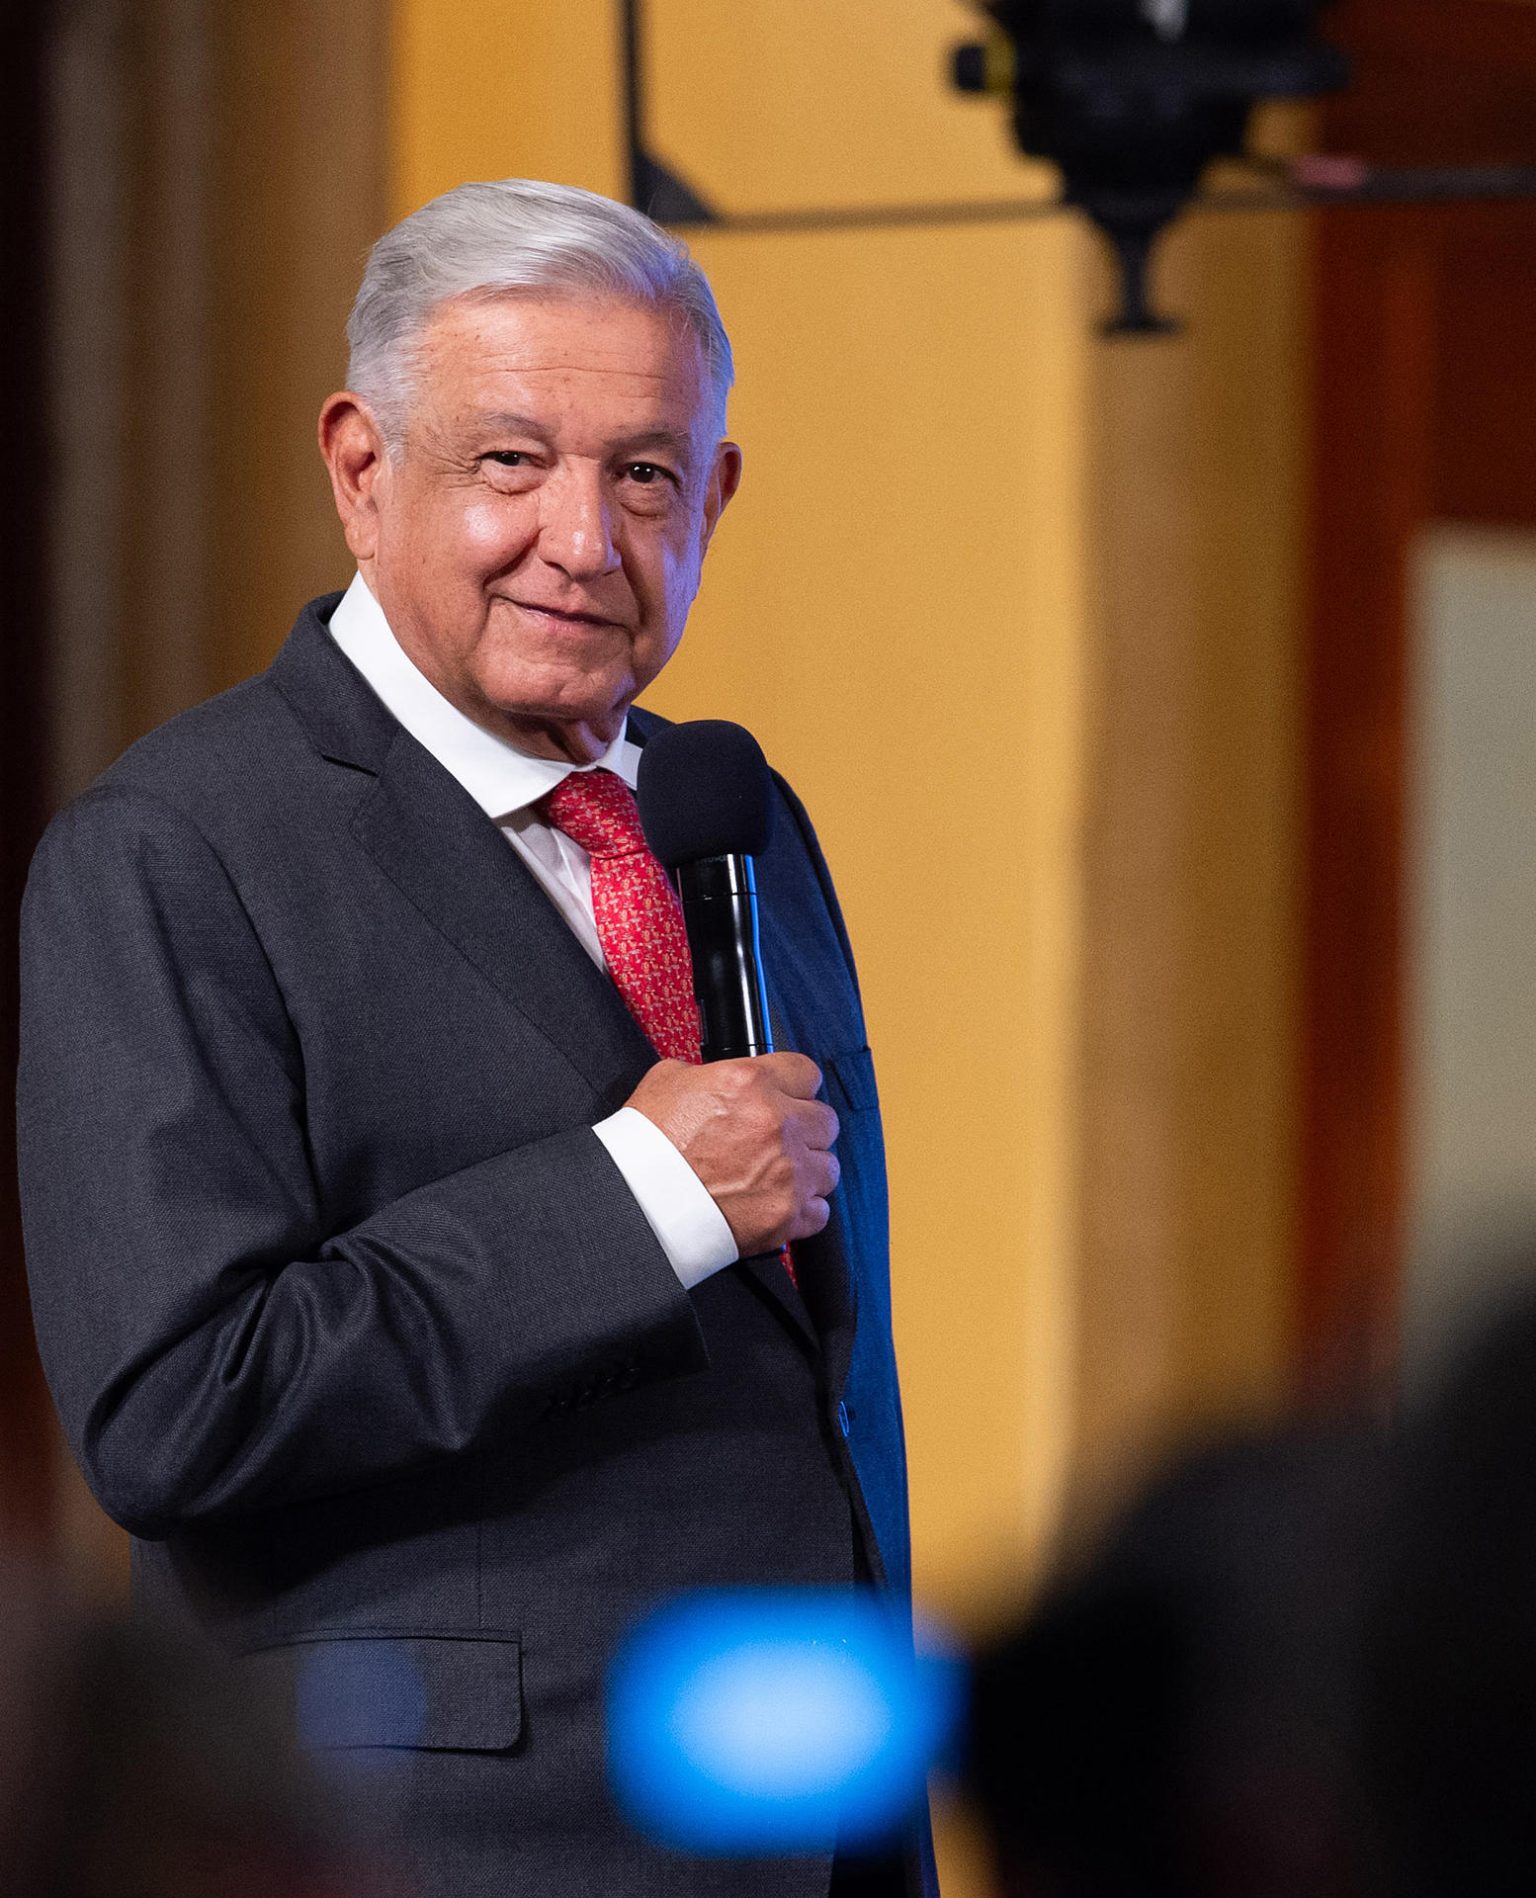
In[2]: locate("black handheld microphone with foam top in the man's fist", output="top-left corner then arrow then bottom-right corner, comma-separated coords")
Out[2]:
636,717 -> 773,1061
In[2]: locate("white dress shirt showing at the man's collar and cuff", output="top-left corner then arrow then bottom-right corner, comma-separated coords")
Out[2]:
330,573 -> 737,1287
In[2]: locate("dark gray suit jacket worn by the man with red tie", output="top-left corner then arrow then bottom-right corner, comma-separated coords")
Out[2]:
21,600 -> 930,1898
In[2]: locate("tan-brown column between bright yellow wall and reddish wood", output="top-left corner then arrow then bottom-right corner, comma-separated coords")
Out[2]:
1075,200 -> 1306,1484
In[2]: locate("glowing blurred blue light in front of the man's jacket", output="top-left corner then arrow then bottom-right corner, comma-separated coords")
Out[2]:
608,1589 -> 959,1852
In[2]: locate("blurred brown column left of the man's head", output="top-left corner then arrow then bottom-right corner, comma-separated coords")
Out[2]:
51,0 -> 389,797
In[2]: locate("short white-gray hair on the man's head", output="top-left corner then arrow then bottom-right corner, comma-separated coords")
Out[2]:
347,178 -> 735,450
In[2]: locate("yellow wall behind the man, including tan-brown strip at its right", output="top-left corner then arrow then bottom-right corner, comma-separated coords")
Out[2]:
391,11 -> 1304,1898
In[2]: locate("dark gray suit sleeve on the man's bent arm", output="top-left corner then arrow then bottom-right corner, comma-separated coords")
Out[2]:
19,790 -> 704,1535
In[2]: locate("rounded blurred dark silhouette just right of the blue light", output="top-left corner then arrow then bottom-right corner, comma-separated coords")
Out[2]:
968,1429 -> 1382,1898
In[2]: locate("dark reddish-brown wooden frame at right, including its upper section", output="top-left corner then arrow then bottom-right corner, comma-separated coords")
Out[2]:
1299,0 -> 1536,1370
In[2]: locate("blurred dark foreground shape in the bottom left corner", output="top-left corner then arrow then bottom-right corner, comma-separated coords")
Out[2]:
0,1573 -> 406,1898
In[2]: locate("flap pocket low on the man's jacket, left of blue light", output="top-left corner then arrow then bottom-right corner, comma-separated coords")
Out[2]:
247,1632 -> 522,1754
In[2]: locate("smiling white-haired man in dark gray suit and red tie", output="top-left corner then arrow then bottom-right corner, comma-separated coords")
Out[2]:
21,180 -> 932,1898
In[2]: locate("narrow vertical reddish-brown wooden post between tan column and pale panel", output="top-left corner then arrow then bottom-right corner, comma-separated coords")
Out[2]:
1301,213 -> 1437,1361
